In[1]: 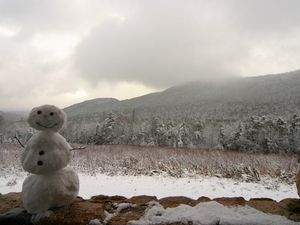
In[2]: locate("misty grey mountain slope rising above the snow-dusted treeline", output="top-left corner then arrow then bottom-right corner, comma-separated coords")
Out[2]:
65,70 -> 300,118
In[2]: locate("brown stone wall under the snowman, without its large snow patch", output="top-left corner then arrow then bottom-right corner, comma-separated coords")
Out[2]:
0,193 -> 300,225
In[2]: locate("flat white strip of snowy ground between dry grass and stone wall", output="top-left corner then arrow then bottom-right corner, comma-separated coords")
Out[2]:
0,173 -> 298,201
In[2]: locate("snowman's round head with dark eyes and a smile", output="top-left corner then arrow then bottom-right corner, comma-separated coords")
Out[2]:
27,105 -> 67,132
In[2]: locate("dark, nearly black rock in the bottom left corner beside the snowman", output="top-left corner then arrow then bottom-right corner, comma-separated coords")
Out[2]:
0,208 -> 33,225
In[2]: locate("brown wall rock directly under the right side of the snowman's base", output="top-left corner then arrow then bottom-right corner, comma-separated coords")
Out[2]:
38,198 -> 104,225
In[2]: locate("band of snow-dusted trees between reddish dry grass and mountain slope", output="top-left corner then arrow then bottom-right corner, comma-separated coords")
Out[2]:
0,111 -> 300,153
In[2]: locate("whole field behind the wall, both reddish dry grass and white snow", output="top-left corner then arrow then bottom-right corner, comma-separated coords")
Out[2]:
0,145 -> 299,201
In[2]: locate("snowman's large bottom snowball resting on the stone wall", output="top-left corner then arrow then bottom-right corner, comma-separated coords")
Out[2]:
22,167 -> 79,214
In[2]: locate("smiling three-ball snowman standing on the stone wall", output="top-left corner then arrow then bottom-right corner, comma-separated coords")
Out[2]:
21,105 -> 79,214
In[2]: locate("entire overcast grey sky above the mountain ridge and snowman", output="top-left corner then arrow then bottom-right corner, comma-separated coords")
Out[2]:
0,0 -> 300,111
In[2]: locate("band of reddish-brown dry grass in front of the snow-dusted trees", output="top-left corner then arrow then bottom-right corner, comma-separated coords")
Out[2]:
0,144 -> 299,183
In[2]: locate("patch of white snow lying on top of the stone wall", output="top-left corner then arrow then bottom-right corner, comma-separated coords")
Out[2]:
128,201 -> 299,225
